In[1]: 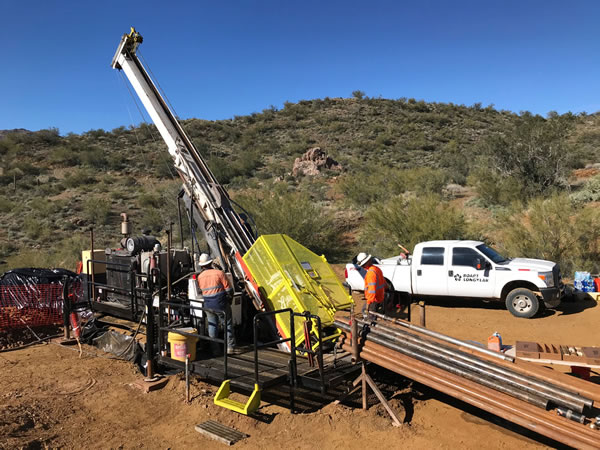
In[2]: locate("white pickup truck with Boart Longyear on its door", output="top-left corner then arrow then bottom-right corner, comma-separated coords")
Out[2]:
345,241 -> 564,318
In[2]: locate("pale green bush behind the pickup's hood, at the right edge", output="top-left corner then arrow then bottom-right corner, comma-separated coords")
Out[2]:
496,194 -> 600,273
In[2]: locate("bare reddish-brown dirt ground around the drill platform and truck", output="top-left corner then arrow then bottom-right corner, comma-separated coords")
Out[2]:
0,284 -> 600,449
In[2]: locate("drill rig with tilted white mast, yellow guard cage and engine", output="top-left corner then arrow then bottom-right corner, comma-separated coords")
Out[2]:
83,28 -> 352,368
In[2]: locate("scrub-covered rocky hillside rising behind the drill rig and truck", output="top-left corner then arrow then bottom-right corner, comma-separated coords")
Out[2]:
0,98 -> 600,271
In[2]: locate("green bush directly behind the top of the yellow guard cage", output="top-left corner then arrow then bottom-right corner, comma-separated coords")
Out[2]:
236,191 -> 341,260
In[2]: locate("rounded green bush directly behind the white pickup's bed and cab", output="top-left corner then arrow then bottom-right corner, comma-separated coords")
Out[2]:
359,194 -> 470,256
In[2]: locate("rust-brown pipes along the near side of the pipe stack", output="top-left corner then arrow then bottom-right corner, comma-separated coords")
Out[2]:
343,343 -> 600,448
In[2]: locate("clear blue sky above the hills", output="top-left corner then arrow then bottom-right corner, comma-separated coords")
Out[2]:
0,0 -> 600,134
